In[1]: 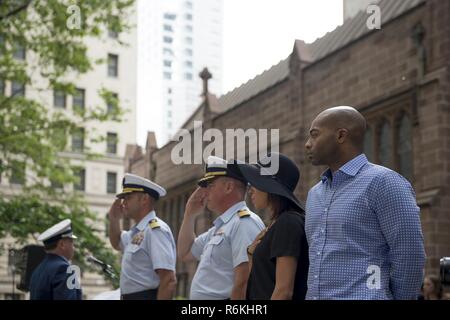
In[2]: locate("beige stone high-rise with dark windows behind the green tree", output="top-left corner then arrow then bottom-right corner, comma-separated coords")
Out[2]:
0,7 -> 137,300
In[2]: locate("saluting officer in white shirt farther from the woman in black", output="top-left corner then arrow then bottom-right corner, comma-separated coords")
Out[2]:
109,173 -> 176,300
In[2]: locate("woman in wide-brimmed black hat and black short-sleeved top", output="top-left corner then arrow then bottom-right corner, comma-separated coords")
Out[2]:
232,153 -> 309,300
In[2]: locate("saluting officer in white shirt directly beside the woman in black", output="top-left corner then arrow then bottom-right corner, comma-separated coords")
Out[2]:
178,156 -> 264,300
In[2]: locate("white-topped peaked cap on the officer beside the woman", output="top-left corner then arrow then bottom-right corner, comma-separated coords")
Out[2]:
198,156 -> 245,188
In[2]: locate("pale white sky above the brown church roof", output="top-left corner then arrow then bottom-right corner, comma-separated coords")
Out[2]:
222,0 -> 343,93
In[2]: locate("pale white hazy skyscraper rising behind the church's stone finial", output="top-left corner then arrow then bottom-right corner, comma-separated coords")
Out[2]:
138,0 -> 223,145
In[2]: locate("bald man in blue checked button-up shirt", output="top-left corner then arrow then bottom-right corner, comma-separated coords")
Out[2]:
305,107 -> 425,300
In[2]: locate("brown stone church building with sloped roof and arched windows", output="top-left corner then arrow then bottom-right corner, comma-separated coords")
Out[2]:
126,0 -> 450,296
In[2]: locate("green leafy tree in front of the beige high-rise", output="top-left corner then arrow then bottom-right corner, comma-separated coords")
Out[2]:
0,0 -> 134,285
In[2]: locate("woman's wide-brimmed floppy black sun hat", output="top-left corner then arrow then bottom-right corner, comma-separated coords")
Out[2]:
233,152 -> 305,211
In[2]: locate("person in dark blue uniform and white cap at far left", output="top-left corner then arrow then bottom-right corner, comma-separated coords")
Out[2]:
30,219 -> 82,300
